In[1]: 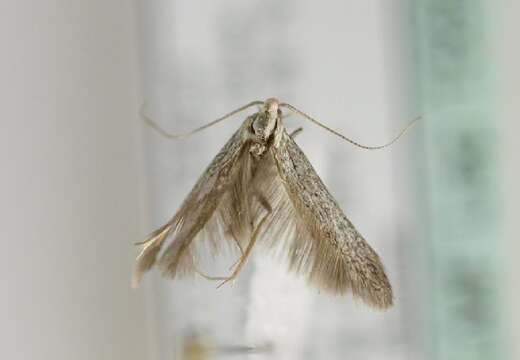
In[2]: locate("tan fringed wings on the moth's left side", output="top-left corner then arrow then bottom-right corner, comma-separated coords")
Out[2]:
134,118 -> 251,285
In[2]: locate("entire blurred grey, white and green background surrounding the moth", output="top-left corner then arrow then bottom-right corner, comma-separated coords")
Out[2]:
0,0 -> 520,360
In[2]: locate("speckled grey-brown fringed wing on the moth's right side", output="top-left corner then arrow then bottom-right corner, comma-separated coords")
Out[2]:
270,129 -> 393,309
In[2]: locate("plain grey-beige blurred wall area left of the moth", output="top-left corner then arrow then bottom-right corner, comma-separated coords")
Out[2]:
0,1 -> 147,360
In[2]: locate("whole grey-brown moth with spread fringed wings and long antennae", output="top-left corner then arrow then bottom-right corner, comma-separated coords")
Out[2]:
134,98 -> 417,309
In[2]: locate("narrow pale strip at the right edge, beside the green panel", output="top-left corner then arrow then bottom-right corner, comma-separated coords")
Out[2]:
494,0 -> 520,359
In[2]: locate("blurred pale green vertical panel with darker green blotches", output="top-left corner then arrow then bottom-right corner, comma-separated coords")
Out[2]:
407,0 -> 508,360
